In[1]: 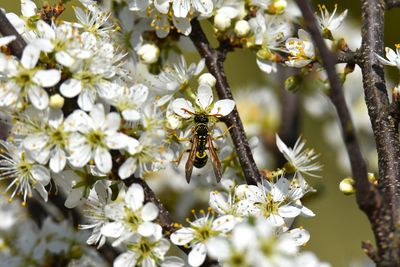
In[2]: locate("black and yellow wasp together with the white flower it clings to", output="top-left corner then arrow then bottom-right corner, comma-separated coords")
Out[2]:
172,84 -> 235,183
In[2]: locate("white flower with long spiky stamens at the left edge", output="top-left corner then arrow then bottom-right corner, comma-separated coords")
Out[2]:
0,140 -> 50,205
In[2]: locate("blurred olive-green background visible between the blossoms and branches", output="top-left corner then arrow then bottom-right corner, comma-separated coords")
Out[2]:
0,0 -> 400,267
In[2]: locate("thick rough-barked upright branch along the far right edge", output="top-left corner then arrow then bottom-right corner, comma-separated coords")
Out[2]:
359,0 -> 400,266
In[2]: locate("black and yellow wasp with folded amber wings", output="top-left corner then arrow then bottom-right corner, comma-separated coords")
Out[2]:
185,114 -> 222,183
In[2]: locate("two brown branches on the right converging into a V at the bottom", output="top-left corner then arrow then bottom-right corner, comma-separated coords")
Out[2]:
296,0 -> 399,266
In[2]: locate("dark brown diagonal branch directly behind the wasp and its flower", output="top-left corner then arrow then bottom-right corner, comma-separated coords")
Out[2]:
189,19 -> 261,184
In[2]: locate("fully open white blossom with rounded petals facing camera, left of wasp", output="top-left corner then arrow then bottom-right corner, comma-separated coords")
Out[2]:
65,104 -> 128,173
